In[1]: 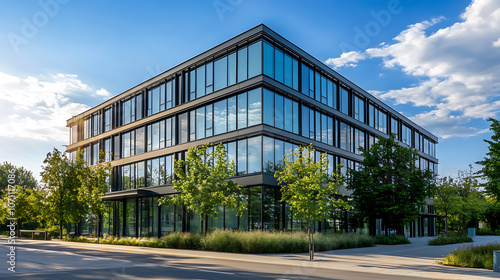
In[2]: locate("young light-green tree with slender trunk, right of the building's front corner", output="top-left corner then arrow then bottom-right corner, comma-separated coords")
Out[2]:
274,145 -> 346,260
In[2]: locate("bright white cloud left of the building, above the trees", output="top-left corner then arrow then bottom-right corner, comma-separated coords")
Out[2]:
0,72 -> 109,143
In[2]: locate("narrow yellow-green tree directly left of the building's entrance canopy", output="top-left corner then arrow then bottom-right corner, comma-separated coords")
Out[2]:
78,150 -> 113,242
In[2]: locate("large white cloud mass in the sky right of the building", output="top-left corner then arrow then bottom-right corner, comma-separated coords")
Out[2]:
328,0 -> 500,137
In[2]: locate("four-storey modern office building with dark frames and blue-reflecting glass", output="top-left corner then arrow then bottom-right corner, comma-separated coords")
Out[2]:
66,25 -> 438,237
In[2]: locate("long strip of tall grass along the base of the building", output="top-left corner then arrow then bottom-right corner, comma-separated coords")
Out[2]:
64,230 -> 375,254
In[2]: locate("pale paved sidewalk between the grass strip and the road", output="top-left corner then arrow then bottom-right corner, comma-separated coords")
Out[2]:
14,236 -> 500,280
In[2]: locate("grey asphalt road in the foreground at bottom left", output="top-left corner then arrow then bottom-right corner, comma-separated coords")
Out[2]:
0,240 -> 442,280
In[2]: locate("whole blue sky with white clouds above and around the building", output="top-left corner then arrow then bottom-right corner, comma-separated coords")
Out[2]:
0,0 -> 500,179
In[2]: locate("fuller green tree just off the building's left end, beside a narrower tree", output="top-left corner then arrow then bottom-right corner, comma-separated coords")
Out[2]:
40,148 -> 88,238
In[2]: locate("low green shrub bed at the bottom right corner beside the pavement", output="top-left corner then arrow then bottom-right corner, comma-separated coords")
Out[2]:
437,243 -> 500,270
